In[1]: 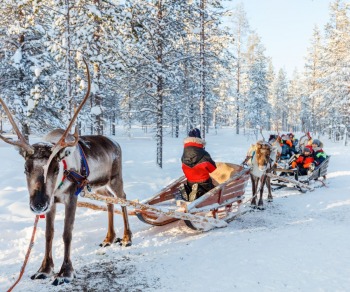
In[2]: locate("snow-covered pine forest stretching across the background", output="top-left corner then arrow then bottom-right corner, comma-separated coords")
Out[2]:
0,0 -> 350,167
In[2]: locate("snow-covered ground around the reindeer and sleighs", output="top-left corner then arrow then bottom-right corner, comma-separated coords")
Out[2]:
0,129 -> 350,292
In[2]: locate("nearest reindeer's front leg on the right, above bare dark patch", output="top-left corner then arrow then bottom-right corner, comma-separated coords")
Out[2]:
52,194 -> 77,286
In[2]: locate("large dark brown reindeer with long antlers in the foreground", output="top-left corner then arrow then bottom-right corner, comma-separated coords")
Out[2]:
0,60 -> 132,285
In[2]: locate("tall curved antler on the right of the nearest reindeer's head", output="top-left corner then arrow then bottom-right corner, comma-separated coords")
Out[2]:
44,58 -> 91,182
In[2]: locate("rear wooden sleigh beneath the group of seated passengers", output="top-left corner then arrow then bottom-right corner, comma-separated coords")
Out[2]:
269,156 -> 330,193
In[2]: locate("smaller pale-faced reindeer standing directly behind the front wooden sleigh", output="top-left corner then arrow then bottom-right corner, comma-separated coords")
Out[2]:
247,141 -> 278,210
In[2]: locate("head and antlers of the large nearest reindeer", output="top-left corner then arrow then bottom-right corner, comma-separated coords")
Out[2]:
0,60 -> 91,214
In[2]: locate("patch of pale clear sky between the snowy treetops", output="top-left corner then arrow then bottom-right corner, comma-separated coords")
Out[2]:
228,0 -> 332,77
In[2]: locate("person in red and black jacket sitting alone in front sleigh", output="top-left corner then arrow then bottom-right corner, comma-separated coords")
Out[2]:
180,128 -> 216,201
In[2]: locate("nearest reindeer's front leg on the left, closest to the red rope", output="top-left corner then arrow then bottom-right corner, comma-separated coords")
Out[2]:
31,203 -> 56,280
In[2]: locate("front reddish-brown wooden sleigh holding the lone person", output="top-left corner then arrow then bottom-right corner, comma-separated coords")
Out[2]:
135,162 -> 250,230
